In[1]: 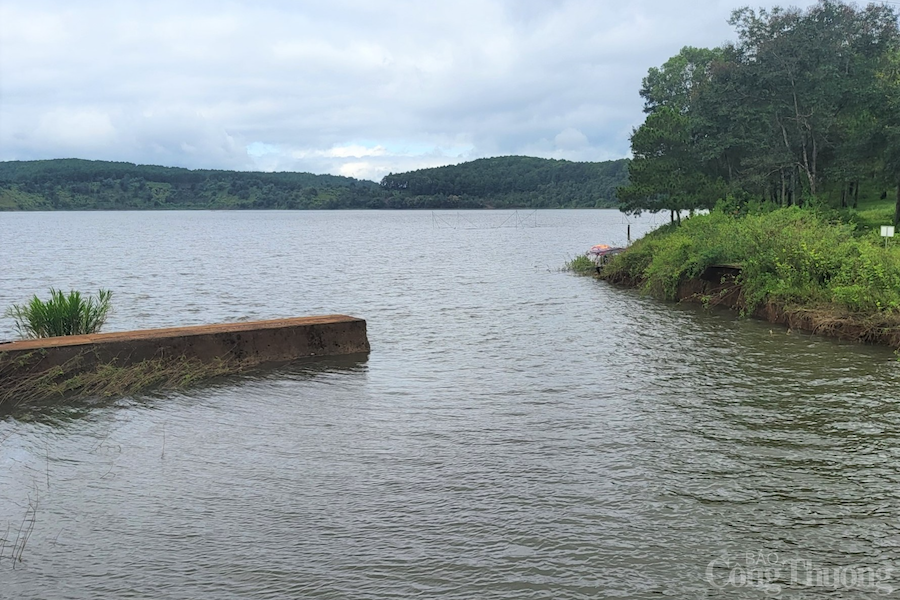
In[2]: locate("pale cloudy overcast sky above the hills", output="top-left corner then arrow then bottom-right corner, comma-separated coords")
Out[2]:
0,0 -> 811,180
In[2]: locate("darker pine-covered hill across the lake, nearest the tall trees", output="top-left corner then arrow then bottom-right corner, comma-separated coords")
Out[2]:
381,156 -> 628,208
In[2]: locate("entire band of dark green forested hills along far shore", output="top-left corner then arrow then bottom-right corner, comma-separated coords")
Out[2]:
0,157 -> 628,210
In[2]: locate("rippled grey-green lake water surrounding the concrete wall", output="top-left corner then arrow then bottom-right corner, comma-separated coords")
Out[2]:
0,210 -> 900,600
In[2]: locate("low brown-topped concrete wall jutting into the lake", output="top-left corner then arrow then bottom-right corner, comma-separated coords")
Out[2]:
0,315 -> 369,377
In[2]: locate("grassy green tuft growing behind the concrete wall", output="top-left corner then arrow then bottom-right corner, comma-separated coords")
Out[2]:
6,288 -> 112,339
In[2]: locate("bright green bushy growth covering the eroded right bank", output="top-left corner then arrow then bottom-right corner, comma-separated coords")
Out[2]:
604,207 -> 900,325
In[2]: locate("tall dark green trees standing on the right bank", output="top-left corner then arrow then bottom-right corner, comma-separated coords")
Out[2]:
618,0 -> 900,217
